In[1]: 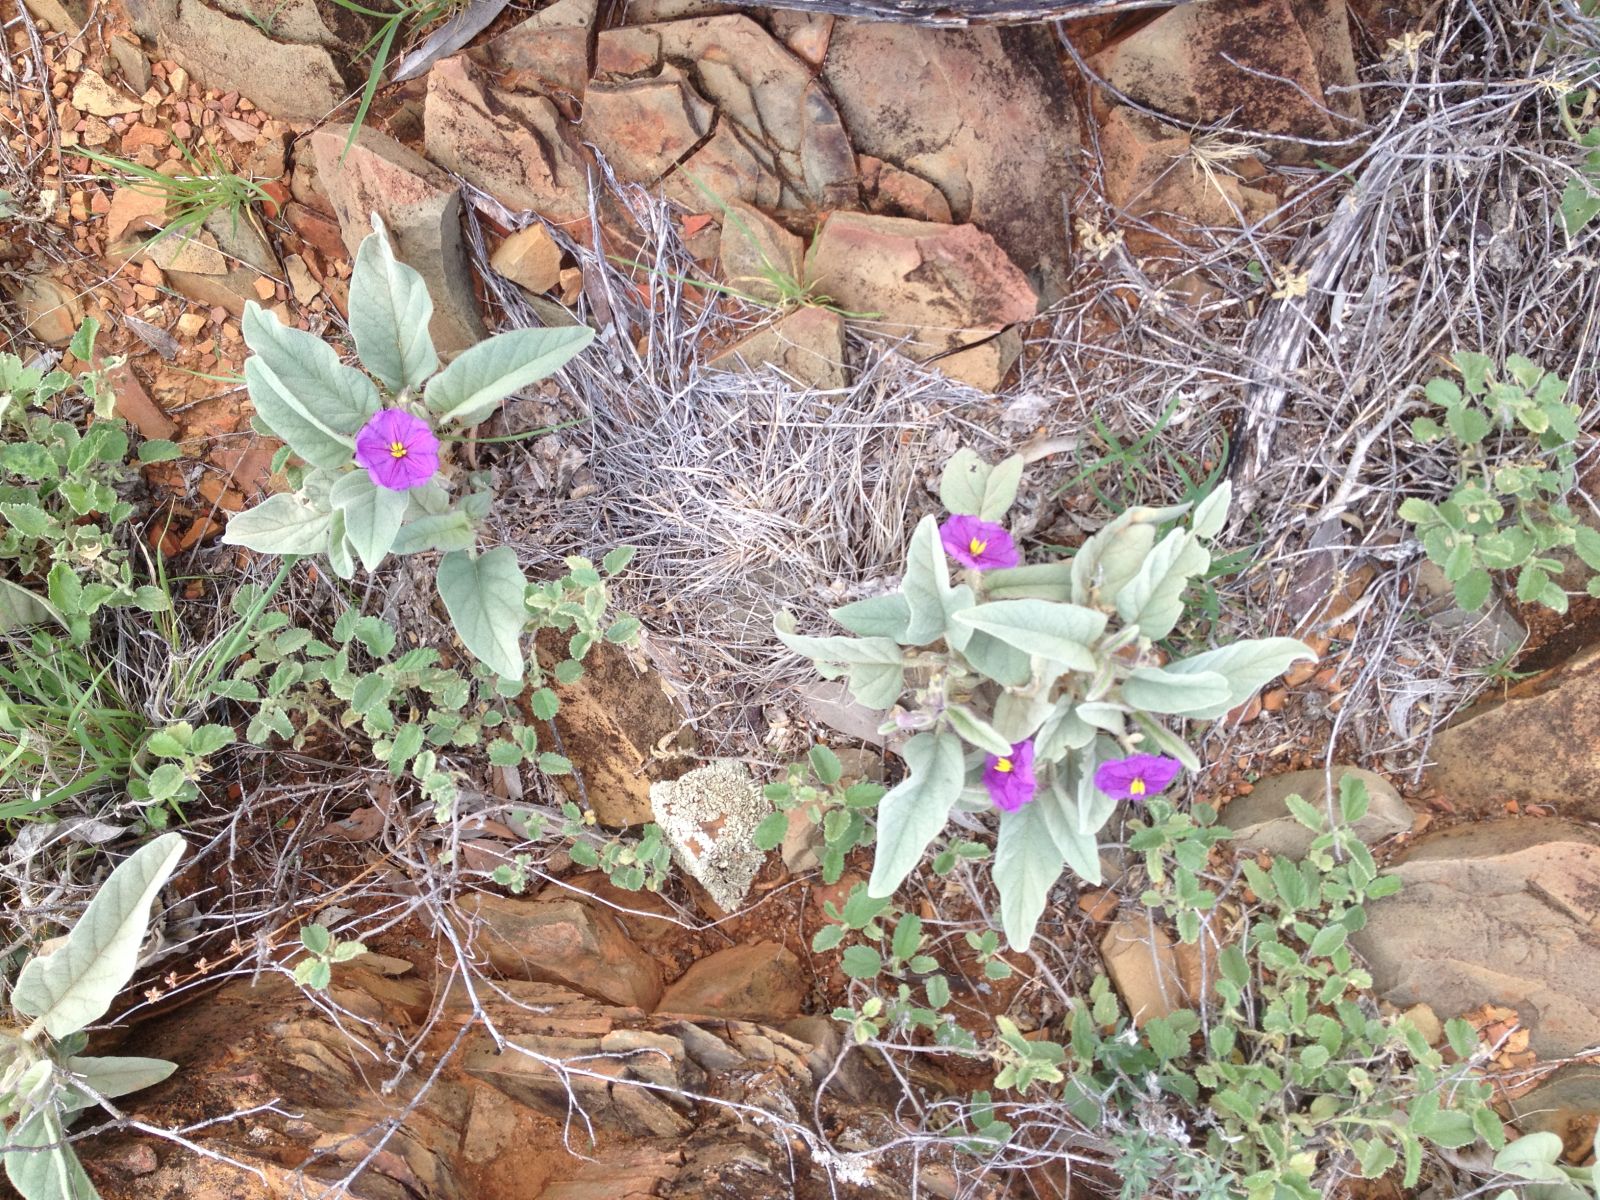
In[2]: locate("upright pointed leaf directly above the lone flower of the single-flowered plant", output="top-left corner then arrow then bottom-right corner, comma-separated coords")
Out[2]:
350,213 -> 438,395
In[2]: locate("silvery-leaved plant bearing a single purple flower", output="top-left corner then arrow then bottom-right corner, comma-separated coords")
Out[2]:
222,216 -> 594,680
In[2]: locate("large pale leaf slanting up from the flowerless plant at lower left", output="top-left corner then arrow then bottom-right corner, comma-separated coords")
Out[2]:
11,834 -> 184,1038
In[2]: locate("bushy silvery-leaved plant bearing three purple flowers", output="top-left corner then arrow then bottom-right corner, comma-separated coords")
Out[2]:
776,450 -> 1312,949
